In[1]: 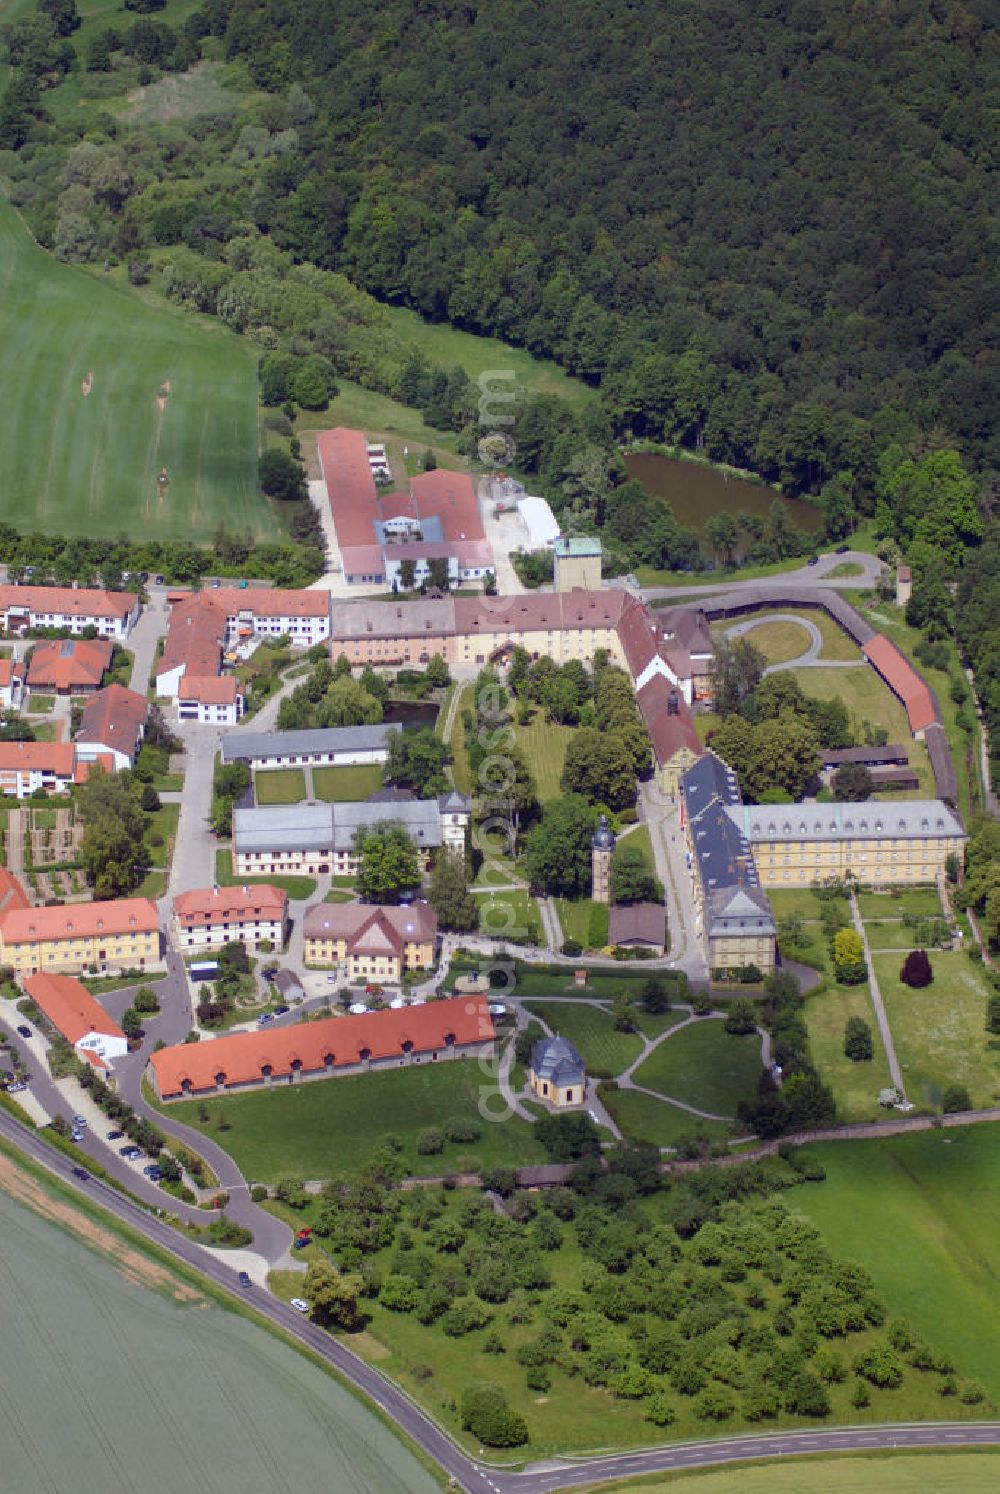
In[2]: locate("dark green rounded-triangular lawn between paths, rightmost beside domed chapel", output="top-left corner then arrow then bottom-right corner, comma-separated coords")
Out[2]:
632,1017 -> 761,1116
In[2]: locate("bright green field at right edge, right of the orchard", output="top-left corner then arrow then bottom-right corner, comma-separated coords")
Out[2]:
794,1125 -> 1000,1404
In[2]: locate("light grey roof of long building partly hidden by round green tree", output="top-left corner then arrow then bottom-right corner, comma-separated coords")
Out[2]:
233,799 -> 442,855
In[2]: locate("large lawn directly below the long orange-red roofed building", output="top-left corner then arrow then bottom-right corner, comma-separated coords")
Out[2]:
164,1059 -> 546,1182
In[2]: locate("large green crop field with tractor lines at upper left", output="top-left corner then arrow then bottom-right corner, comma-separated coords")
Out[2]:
0,194 -> 269,541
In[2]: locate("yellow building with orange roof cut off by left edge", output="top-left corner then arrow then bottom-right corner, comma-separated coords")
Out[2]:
0,898 -> 160,976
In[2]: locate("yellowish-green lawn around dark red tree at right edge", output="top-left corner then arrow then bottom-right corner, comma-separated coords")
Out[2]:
873,950 -> 1000,1107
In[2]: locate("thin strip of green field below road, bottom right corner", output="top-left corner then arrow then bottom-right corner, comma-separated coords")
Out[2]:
601,1448 -> 1000,1494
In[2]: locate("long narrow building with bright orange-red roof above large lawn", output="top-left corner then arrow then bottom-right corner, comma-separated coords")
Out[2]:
148,996 -> 495,1100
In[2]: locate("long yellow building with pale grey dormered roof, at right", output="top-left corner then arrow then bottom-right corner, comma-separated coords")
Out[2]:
726,799 -> 966,887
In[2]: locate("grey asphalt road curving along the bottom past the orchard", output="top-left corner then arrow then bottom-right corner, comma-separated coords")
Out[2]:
0,1112 -> 1000,1494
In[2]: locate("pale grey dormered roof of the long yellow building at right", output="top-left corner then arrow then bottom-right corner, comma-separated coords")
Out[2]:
726,799 -> 964,841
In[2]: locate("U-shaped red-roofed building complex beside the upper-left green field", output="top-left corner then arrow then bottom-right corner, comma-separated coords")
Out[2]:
318,426 -> 495,590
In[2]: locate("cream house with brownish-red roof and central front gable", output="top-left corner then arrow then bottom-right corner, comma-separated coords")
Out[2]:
302,902 -> 438,985
